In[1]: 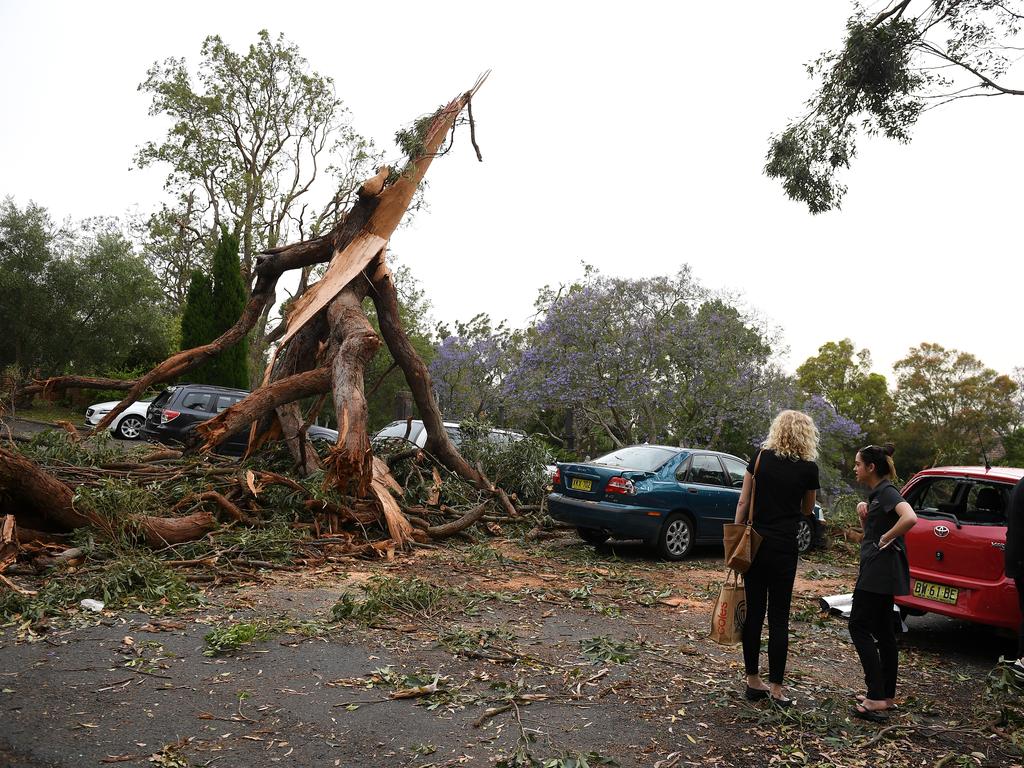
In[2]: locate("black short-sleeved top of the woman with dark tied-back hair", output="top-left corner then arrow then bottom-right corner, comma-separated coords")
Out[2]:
857,480 -> 910,595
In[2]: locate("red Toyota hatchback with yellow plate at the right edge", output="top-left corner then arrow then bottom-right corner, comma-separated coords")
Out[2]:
896,467 -> 1024,630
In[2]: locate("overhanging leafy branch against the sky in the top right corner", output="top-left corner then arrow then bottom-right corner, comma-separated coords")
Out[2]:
765,0 -> 1024,213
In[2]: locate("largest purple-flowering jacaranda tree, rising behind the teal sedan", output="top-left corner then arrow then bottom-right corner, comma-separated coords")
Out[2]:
505,267 -> 785,454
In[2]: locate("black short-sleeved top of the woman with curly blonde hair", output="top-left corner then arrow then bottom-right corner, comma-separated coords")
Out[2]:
746,449 -> 821,552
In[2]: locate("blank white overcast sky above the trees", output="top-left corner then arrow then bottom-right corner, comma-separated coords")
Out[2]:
0,0 -> 1024,382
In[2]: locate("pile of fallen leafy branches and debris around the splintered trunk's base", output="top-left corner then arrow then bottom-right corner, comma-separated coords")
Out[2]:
0,424 -> 547,622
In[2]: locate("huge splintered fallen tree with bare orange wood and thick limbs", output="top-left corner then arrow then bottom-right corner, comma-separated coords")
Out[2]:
0,76 -> 517,561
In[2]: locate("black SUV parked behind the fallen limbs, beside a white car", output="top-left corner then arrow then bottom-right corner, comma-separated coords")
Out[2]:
145,384 -> 249,456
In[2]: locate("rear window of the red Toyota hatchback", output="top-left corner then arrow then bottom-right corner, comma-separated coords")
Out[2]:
907,477 -> 1011,525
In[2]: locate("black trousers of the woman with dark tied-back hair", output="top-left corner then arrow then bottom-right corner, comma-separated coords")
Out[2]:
850,590 -> 899,700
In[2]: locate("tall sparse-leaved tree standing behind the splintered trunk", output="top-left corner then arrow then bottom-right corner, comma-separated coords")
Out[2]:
136,30 -> 375,304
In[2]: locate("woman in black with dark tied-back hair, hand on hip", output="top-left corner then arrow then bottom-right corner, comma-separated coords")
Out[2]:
850,442 -> 918,722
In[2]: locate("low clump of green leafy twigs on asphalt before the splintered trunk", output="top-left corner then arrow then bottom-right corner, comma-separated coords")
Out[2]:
331,575 -> 473,625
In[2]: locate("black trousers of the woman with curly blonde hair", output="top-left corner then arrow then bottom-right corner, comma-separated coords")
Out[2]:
742,542 -> 797,685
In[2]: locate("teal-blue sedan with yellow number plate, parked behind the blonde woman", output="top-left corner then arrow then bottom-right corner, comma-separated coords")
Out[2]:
548,444 -> 824,560
